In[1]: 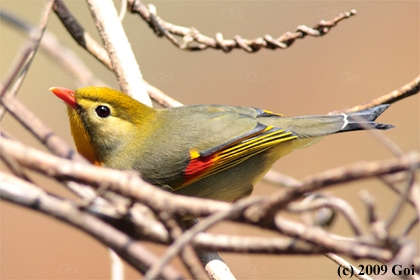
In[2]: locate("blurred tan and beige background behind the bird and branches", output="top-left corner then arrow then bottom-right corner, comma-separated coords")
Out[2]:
0,0 -> 420,279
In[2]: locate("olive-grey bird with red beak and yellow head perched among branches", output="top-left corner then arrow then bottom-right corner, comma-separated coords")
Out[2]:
50,87 -> 394,202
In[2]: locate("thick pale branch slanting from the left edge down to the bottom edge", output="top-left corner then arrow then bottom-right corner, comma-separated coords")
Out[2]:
0,172 -> 181,279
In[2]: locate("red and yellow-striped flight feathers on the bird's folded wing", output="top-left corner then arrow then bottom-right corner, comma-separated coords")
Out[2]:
181,124 -> 297,188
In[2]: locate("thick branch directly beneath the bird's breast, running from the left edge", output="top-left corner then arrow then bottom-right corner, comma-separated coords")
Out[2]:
0,138 -> 231,217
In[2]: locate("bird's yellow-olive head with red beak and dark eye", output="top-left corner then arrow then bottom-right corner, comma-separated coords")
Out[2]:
50,87 -> 156,165
